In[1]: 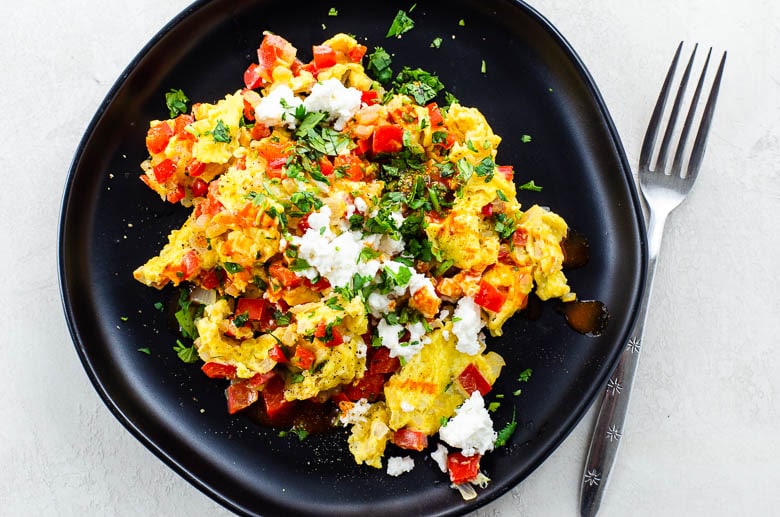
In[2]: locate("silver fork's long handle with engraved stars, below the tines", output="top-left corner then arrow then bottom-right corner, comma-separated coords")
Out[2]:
580,213 -> 666,517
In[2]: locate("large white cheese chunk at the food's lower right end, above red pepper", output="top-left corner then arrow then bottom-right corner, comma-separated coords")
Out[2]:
439,391 -> 497,456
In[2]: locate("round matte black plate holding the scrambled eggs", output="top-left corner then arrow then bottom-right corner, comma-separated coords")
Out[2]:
59,0 -> 645,516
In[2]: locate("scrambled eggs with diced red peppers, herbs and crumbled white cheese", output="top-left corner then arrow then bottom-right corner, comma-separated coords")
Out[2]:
134,33 -> 575,495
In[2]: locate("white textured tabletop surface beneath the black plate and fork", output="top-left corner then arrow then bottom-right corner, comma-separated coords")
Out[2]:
0,0 -> 780,517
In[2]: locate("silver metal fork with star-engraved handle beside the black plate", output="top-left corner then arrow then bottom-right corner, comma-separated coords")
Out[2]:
580,42 -> 726,517
